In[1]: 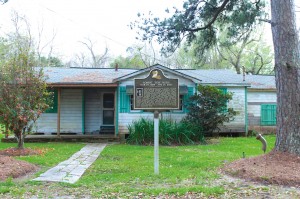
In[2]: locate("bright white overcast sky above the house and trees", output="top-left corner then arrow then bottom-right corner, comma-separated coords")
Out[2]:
0,0 -> 300,61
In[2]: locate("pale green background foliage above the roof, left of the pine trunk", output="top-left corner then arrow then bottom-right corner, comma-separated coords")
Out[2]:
185,26 -> 274,74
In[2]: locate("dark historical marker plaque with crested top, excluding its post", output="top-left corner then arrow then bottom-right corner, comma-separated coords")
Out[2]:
134,69 -> 179,110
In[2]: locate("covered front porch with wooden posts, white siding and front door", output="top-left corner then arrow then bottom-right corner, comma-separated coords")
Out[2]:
37,85 -> 118,137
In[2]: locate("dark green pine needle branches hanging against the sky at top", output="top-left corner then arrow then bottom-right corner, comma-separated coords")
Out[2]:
131,0 -> 265,53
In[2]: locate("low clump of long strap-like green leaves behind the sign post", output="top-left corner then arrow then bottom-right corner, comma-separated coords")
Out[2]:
126,118 -> 204,145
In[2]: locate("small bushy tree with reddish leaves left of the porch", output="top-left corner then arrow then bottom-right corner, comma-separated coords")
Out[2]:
0,12 -> 51,148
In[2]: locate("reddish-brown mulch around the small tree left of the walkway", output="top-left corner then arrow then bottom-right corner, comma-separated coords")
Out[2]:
0,148 -> 42,181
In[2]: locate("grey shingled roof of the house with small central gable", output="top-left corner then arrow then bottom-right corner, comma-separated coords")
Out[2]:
40,64 -> 276,89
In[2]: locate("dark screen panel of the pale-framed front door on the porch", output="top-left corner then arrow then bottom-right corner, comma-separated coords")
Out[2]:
102,93 -> 115,126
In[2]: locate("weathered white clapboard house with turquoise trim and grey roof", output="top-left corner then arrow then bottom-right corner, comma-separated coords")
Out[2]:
34,64 -> 276,136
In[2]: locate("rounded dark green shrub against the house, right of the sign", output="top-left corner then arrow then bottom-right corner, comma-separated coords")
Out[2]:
184,85 -> 236,134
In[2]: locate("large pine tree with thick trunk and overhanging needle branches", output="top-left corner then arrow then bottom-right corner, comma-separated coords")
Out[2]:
135,0 -> 300,155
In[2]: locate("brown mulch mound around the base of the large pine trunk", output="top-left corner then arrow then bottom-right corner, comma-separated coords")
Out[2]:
222,151 -> 300,188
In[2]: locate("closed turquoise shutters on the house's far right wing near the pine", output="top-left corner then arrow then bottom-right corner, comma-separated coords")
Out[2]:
260,104 -> 276,126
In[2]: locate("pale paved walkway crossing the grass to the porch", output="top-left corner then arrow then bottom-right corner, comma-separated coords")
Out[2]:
33,143 -> 106,183
